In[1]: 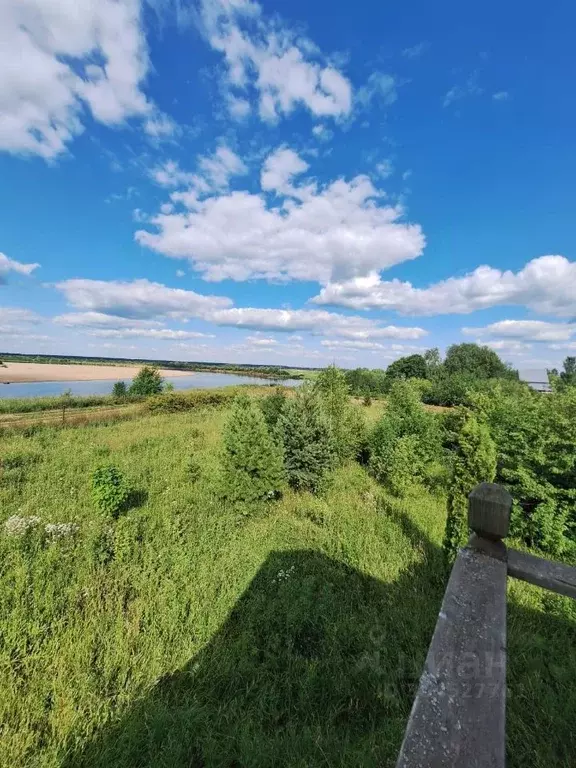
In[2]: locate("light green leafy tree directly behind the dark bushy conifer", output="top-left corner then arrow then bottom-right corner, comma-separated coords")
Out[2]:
314,365 -> 365,462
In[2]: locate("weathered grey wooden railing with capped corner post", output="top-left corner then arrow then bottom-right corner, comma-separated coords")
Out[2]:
397,483 -> 576,768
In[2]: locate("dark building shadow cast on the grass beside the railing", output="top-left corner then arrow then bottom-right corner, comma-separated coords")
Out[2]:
62,514 -> 573,768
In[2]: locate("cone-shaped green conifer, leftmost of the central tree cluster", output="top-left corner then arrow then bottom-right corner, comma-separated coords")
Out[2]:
222,395 -> 284,502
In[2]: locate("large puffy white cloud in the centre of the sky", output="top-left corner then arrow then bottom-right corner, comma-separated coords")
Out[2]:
136,147 -> 425,284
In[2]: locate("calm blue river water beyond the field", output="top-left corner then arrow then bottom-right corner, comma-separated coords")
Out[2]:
0,373 -> 302,398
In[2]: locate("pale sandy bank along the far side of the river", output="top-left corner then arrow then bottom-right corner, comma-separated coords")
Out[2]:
0,363 -> 193,384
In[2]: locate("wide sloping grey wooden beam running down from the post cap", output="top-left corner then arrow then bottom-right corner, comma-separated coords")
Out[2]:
397,549 -> 506,768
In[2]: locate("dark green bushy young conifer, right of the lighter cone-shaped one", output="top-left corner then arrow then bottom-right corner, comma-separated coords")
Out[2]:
277,387 -> 336,492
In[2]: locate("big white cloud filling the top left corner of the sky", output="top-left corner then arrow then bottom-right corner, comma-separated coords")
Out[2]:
0,0 -> 173,159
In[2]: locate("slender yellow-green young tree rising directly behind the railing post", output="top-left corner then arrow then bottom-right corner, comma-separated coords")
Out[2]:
442,408 -> 496,566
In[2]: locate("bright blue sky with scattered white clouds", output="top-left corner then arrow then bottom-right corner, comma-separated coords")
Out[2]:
0,0 -> 576,370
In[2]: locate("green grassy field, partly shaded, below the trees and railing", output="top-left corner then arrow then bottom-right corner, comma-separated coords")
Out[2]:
0,403 -> 576,768
